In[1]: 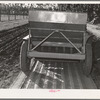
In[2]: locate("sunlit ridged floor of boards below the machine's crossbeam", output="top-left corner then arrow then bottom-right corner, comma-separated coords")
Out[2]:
24,59 -> 97,89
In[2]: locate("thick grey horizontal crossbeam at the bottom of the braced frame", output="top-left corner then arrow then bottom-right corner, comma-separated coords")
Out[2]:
28,51 -> 85,60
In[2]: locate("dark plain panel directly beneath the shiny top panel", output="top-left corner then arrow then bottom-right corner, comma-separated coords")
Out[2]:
29,21 -> 86,31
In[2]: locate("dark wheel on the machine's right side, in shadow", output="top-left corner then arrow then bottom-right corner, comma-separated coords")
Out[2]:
83,44 -> 92,76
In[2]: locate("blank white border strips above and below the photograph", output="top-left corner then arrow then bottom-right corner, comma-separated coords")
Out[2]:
0,1 -> 100,99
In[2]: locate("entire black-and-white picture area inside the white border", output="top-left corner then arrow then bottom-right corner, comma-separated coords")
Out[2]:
0,2 -> 100,92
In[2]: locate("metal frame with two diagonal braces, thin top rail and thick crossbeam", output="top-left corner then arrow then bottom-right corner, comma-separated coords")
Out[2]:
27,28 -> 85,60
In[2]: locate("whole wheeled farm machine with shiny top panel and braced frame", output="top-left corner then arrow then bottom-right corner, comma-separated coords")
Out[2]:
20,10 -> 97,88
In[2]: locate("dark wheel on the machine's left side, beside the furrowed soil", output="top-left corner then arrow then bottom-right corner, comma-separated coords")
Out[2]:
20,41 -> 30,76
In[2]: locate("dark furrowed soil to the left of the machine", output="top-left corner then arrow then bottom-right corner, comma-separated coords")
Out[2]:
0,24 -> 28,88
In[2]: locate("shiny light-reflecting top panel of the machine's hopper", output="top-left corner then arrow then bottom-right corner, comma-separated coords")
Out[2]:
29,11 -> 87,24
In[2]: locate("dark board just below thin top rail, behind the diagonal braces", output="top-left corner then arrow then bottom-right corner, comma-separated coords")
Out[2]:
29,28 -> 83,38
